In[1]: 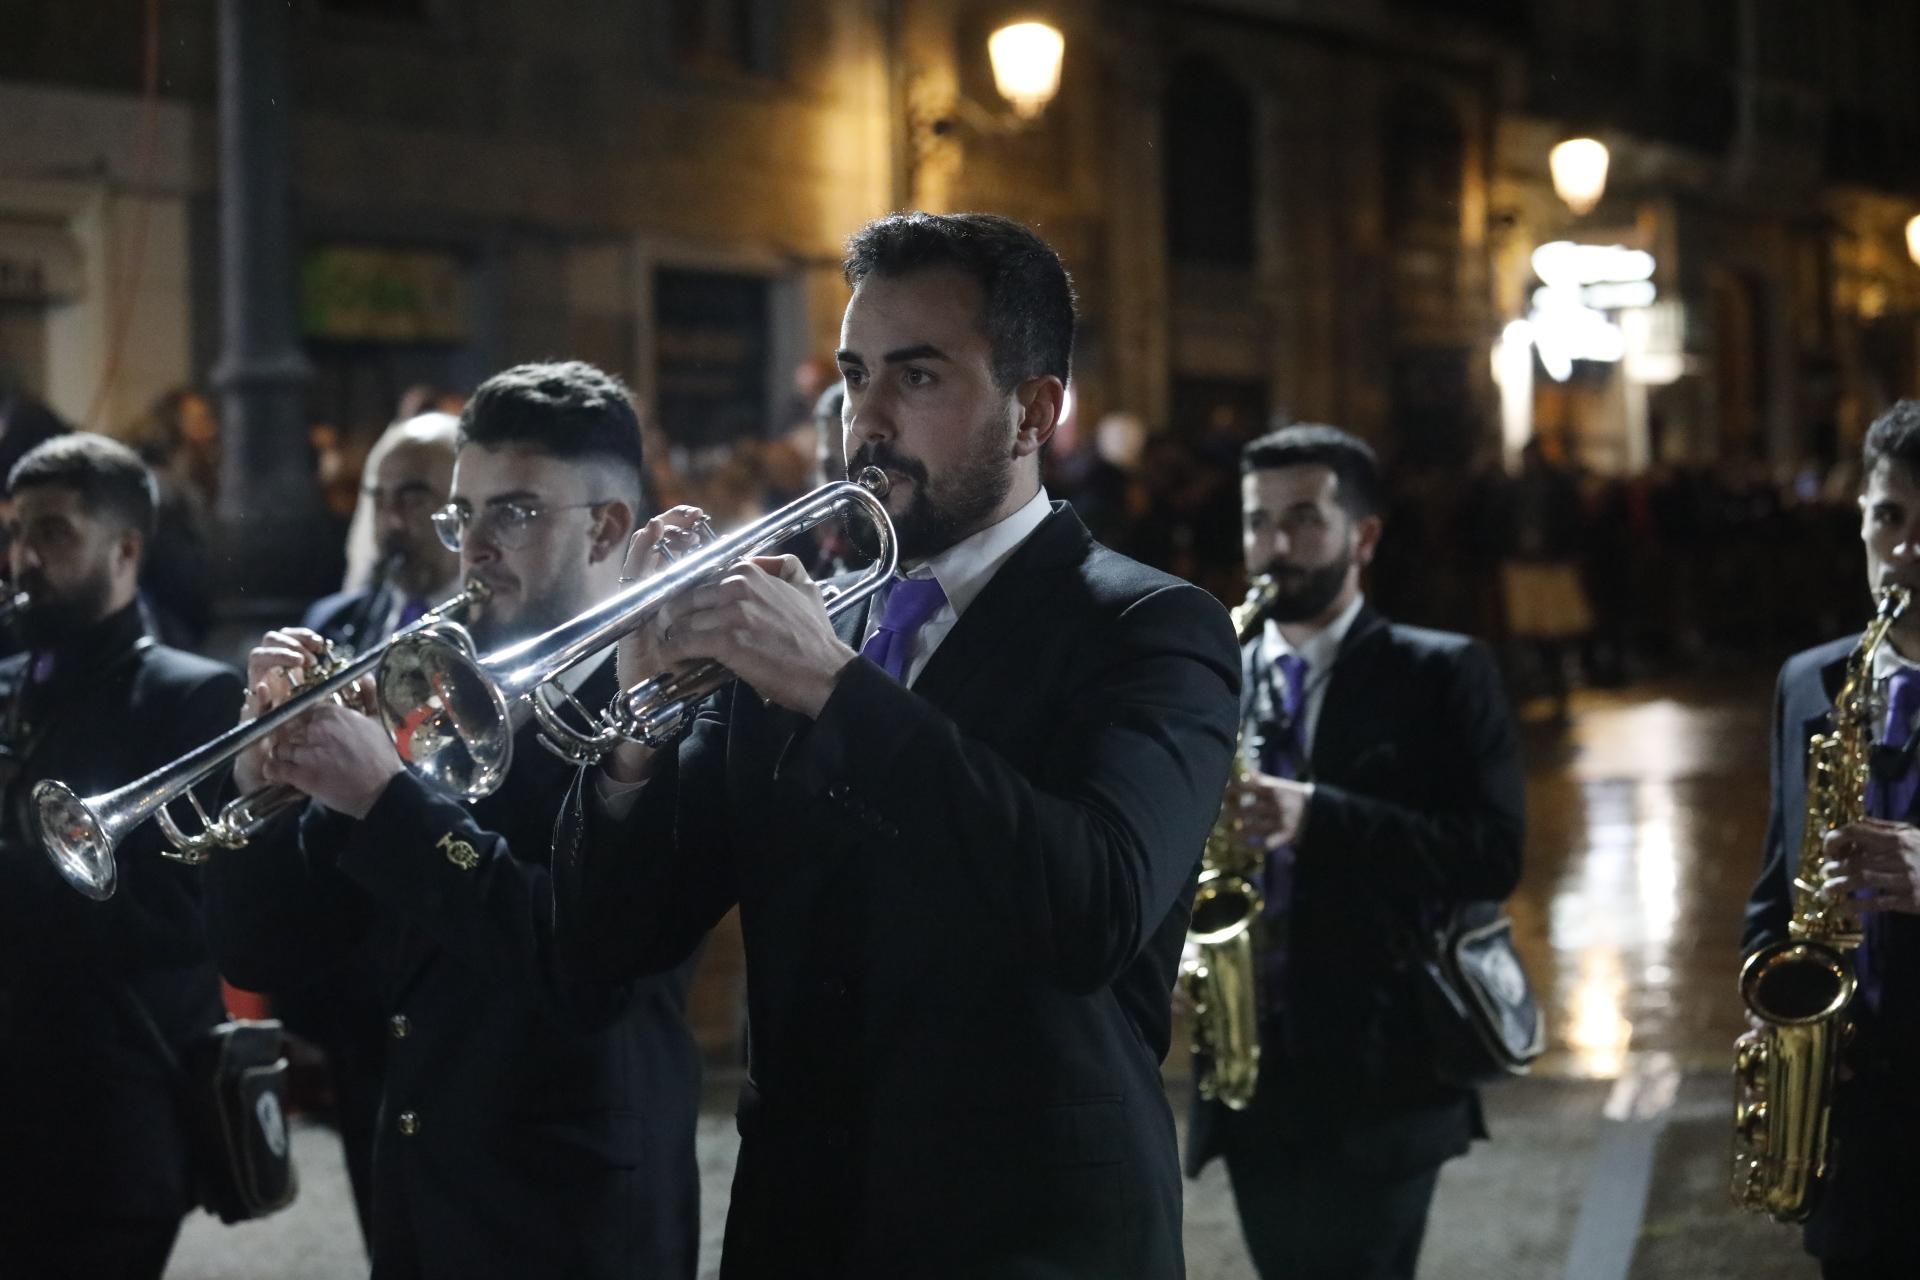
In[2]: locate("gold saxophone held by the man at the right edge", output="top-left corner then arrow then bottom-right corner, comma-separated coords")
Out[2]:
1732,587 -> 1910,1222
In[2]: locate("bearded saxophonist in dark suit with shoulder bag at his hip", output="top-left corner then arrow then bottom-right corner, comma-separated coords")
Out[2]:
1187,426 -> 1524,1280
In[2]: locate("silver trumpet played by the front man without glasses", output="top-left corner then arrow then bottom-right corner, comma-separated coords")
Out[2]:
374,466 -> 899,800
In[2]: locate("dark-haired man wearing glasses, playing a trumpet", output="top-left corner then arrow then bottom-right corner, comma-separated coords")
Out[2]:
207,363 -> 699,1280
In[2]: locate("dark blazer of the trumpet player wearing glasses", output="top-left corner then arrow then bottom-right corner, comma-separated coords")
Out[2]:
207,662 -> 699,1280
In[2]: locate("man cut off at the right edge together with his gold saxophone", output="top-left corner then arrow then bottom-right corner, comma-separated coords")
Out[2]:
1734,399 -> 1920,1280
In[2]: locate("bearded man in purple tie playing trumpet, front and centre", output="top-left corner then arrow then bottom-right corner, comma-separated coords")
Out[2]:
557,213 -> 1238,1280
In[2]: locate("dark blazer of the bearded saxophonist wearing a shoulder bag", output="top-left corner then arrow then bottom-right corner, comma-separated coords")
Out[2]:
1187,604 -> 1526,1180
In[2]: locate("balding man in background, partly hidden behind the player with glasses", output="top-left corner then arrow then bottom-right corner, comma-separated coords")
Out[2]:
273,413 -> 461,1245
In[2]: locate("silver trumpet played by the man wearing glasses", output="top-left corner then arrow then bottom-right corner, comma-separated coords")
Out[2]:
31,581 -> 488,902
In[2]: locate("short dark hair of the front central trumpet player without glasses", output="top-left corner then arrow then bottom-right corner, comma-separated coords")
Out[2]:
843,213 -> 1073,391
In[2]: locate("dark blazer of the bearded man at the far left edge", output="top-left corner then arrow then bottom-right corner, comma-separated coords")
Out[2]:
0,606 -> 240,1220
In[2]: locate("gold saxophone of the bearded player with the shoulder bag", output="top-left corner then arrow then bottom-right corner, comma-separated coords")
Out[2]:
1179,576 -> 1275,1111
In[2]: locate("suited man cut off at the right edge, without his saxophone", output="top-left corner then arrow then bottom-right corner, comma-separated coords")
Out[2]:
1741,399 -> 1920,1280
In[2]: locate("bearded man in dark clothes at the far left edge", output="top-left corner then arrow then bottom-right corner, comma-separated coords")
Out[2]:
0,434 -> 240,1278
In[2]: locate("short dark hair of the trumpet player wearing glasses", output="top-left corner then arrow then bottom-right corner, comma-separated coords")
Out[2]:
455,361 -> 647,516
